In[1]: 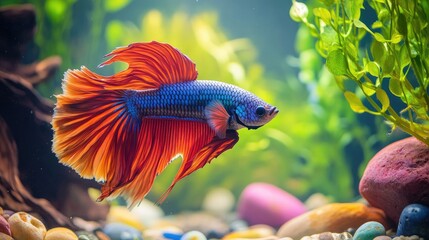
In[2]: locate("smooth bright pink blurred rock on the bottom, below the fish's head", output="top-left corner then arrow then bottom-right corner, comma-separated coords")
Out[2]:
237,183 -> 307,228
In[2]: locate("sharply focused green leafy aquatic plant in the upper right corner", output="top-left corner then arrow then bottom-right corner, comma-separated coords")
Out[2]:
290,0 -> 429,145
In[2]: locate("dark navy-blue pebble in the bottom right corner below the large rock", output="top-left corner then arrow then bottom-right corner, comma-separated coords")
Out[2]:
396,204 -> 429,239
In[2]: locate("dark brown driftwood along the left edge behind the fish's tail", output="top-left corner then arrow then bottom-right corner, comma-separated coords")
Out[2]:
0,5 -> 108,229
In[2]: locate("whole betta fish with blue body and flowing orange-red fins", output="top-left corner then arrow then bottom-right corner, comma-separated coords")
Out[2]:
52,42 -> 279,205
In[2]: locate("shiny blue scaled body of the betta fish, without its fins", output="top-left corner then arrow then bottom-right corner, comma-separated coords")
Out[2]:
125,80 -> 264,122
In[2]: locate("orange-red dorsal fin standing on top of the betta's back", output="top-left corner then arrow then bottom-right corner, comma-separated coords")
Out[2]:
99,41 -> 198,90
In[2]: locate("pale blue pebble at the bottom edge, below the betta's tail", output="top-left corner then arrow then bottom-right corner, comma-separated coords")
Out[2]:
103,223 -> 143,240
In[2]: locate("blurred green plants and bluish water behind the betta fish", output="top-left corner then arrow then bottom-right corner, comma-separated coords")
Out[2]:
0,0 -> 401,212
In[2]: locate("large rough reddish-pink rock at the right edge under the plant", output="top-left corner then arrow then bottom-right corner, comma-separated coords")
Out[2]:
359,138 -> 429,223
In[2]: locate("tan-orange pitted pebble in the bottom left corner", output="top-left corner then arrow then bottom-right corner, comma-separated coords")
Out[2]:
8,212 -> 46,240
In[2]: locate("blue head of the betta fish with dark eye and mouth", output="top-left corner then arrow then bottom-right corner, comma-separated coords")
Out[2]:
233,99 -> 279,129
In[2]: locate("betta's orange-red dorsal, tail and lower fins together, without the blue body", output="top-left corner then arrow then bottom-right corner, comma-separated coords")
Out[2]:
52,42 -> 238,204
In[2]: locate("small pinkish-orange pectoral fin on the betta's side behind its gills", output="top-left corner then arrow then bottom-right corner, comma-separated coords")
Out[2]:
204,100 -> 231,138
